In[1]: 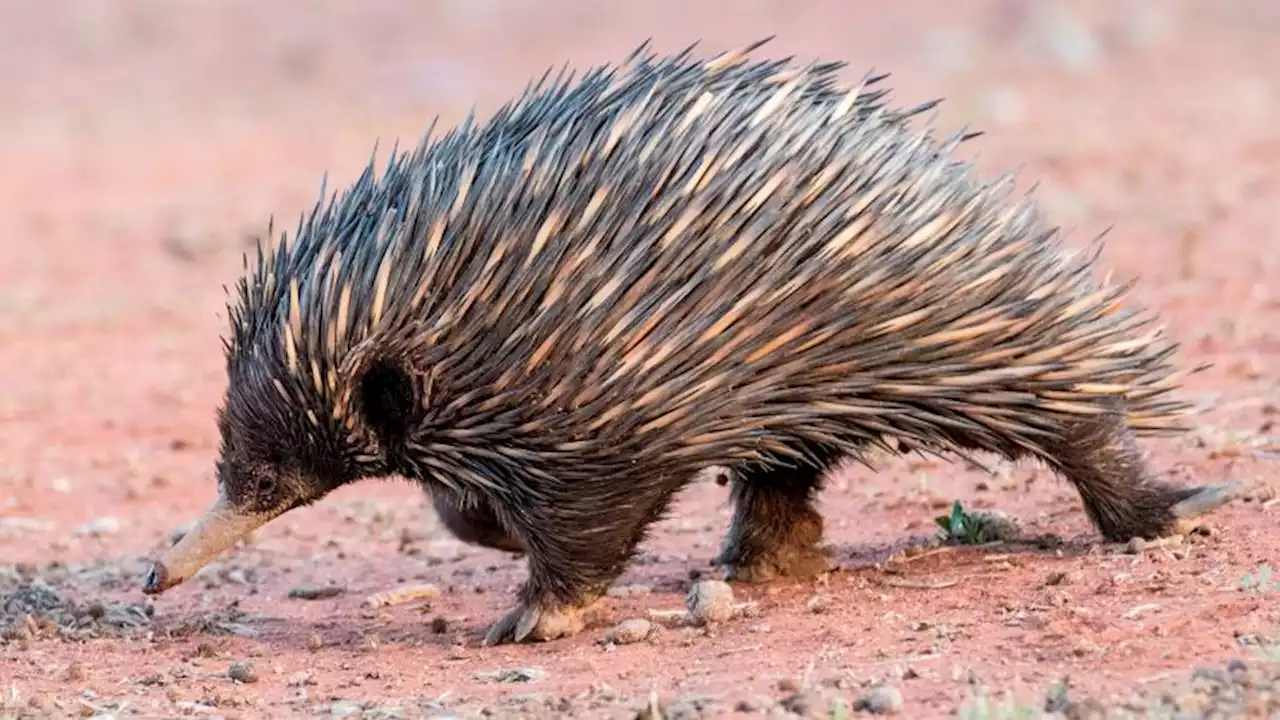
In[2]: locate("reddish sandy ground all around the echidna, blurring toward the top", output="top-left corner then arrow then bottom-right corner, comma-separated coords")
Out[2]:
0,0 -> 1280,717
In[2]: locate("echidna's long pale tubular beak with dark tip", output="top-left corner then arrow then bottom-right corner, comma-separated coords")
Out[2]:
142,497 -> 273,594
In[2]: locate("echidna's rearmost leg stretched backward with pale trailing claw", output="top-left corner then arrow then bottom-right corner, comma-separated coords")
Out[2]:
1052,402 -> 1231,542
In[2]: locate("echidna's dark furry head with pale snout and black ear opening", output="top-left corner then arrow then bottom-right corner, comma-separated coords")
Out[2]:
143,340 -> 412,594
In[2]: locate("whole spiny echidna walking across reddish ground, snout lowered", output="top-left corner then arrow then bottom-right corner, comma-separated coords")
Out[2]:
146,44 -> 1228,643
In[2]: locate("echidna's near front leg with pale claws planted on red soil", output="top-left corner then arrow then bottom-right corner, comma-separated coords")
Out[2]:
484,482 -> 676,646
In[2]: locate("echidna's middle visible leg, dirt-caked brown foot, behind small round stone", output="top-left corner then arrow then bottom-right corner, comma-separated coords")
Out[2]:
713,468 -> 829,583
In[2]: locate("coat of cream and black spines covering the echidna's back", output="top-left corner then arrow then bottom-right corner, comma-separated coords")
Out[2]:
236,43 -> 1183,481
